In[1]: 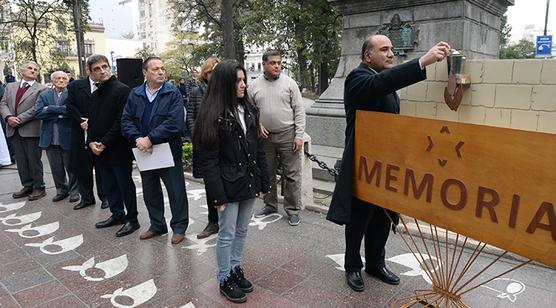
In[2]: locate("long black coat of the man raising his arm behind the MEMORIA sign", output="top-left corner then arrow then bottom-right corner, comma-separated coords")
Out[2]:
326,59 -> 427,224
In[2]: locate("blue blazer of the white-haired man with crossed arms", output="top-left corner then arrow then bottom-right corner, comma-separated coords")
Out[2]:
35,89 -> 71,151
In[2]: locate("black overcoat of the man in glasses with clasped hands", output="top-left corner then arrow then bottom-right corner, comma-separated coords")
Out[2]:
87,76 -> 133,165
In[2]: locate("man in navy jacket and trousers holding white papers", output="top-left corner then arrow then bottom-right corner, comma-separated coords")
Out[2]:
122,57 -> 189,244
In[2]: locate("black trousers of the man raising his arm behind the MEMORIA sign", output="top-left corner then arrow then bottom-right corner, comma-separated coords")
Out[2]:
344,199 -> 391,272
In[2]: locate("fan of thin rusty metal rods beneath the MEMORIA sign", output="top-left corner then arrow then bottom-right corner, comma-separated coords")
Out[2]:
386,212 -> 531,308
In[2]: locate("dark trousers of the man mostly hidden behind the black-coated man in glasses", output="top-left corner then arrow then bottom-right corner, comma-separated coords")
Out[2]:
72,146 -> 106,203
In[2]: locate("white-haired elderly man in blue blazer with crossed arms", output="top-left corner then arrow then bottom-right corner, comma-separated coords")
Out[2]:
35,71 -> 79,202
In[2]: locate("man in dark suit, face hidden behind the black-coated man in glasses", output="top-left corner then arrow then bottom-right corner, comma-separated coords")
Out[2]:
66,66 -> 108,210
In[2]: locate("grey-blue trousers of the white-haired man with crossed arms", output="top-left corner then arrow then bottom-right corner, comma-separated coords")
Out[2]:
46,145 -> 78,196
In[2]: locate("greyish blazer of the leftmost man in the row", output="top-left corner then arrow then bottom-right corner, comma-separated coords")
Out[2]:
0,81 -> 46,137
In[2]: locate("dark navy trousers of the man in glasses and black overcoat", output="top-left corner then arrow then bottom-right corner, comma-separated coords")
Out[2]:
96,161 -> 137,222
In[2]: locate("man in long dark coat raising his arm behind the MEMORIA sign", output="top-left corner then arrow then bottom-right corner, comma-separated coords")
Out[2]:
327,35 -> 450,292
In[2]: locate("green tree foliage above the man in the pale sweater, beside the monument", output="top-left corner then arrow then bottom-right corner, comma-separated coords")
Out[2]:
169,0 -> 341,93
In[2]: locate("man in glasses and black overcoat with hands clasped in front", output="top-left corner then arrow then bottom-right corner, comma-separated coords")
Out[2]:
87,55 -> 139,237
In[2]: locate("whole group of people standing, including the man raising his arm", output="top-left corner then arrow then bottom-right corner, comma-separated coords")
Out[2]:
0,35 -> 450,303
